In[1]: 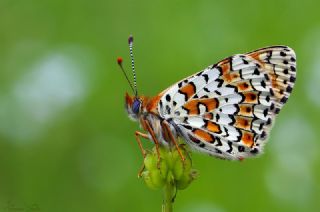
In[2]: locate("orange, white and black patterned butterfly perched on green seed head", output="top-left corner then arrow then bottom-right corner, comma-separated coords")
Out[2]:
118,36 -> 296,160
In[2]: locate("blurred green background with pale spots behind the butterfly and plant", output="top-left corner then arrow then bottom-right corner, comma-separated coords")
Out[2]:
0,0 -> 320,212
